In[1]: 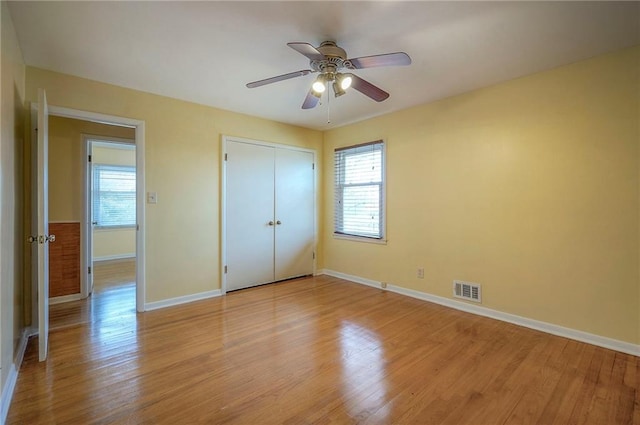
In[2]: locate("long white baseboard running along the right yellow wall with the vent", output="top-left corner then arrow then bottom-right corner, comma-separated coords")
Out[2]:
322,269 -> 640,357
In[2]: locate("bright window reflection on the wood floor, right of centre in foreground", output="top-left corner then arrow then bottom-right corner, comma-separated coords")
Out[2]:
340,321 -> 388,422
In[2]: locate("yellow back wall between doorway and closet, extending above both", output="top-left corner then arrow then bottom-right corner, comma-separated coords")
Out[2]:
26,67 -> 322,302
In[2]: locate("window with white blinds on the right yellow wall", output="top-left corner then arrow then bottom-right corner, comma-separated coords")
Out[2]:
334,141 -> 385,239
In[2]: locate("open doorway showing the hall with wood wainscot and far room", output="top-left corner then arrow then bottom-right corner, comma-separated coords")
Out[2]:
48,116 -> 137,329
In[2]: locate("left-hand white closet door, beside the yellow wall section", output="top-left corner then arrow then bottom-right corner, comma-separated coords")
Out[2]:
226,142 -> 276,291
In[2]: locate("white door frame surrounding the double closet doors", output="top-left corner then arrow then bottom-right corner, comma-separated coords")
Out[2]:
219,135 -> 319,295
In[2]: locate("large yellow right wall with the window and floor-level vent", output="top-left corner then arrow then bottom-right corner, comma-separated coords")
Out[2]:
323,47 -> 640,344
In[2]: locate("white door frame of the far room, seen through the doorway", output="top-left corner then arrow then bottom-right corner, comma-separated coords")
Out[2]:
80,133 -> 138,298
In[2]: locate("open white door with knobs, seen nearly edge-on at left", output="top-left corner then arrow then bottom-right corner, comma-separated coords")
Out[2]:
32,89 -> 50,361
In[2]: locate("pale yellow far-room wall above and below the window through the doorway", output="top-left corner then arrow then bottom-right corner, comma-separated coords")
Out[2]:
92,144 -> 136,261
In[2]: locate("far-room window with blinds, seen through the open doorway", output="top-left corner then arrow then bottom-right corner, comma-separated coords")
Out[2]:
93,164 -> 136,227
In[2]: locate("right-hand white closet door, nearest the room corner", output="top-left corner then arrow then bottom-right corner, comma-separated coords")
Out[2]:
275,148 -> 315,280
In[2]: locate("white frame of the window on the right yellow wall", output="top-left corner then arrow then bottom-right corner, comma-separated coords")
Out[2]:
333,140 -> 387,244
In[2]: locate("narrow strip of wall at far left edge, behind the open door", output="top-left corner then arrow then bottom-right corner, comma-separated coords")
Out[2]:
0,1 -> 26,392
